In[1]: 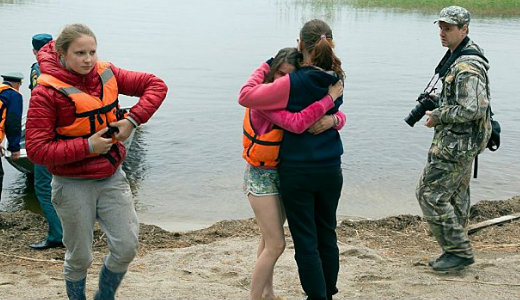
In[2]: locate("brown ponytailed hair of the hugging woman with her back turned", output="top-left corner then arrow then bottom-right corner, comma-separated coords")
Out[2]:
300,19 -> 345,78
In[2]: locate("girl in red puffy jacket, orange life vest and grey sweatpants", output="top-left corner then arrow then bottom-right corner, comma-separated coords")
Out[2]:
26,24 -> 167,300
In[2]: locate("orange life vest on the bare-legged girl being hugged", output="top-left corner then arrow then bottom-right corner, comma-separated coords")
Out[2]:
242,108 -> 283,167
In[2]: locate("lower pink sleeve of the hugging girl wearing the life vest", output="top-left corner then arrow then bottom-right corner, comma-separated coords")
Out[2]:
255,94 -> 334,134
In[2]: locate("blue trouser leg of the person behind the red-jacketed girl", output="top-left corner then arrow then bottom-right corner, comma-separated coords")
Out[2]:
34,165 -> 63,242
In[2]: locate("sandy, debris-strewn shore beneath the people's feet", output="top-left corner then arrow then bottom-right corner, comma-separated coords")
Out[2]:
0,196 -> 520,299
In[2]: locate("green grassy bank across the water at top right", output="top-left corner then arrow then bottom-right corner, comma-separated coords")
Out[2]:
306,0 -> 520,17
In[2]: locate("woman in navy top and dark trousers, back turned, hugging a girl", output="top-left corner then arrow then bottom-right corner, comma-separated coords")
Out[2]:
239,19 -> 344,300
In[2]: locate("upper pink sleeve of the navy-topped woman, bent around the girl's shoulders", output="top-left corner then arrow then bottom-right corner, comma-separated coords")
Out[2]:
238,63 -> 291,110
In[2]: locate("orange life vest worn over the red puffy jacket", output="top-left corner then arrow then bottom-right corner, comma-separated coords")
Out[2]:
38,62 -> 121,142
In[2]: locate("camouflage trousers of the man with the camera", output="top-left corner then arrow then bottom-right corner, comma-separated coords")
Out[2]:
416,153 -> 473,257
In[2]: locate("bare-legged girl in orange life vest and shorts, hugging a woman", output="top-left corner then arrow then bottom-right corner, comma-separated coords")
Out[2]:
242,48 -> 345,300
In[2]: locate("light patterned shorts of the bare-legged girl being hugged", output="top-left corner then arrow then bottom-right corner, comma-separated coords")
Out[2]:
243,164 -> 280,196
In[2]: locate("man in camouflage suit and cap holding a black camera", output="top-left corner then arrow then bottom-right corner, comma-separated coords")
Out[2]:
416,6 -> 491,271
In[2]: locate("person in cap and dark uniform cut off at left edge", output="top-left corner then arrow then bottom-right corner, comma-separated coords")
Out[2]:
0,72 -> 23,200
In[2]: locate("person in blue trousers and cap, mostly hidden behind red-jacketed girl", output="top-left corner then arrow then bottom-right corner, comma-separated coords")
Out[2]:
29,33 -> 63,250
